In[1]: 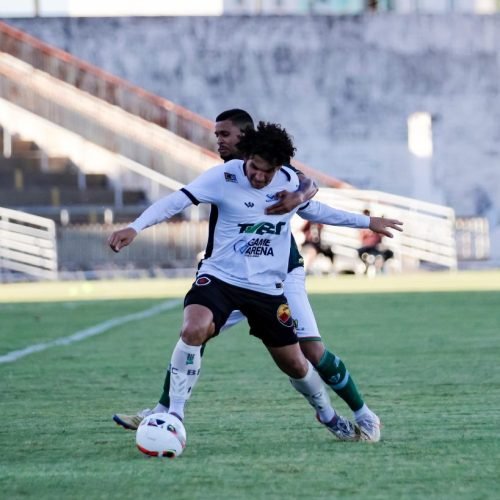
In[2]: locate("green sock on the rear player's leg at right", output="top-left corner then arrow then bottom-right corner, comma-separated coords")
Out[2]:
315,349 -> 364,411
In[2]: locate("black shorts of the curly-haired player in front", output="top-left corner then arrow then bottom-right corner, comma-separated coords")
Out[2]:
184,274 -> 298,347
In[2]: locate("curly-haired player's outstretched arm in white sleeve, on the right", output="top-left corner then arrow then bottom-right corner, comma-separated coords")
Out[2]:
297,201 -> 403,238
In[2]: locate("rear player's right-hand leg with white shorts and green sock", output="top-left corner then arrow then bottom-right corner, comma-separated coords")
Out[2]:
284,267 -> 378,440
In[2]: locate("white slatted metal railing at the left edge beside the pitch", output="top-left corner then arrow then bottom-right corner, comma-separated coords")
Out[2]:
0,207 -> 58,280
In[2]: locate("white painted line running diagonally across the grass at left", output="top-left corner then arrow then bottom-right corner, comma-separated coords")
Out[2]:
0,299 -> 182,364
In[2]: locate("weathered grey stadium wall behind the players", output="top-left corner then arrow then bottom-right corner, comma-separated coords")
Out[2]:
7,14 -> 500,258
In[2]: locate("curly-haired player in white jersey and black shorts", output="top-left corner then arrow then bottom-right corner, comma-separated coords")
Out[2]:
109,123 -> 400,440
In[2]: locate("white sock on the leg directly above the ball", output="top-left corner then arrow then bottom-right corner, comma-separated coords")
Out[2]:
168,339 -> 201,419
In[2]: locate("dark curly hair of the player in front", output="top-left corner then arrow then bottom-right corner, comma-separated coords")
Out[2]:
238,121 -> 296,166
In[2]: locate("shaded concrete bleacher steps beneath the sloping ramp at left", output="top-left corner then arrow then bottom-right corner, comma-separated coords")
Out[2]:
0,129 -> 147,223
